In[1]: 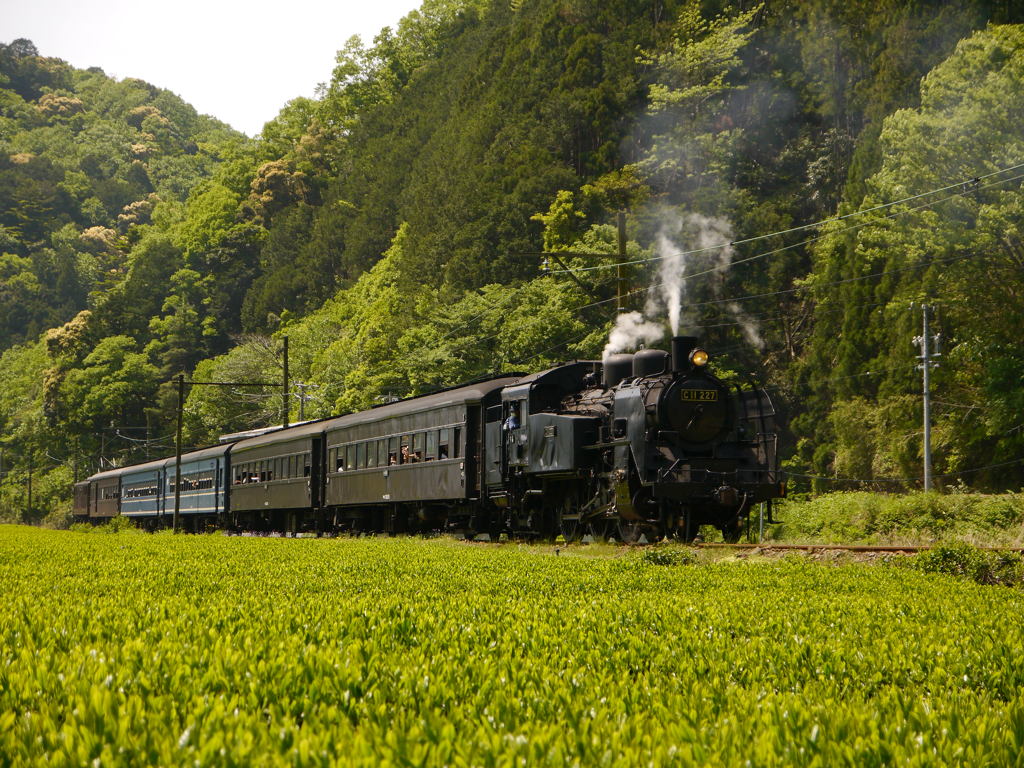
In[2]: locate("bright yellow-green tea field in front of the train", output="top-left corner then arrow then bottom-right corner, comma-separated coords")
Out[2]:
0,526 -> 1024,766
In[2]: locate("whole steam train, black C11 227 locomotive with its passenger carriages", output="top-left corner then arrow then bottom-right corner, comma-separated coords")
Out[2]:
75,336 -> 785,542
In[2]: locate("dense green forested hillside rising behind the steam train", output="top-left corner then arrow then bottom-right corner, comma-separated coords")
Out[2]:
0,0 -> 1024,521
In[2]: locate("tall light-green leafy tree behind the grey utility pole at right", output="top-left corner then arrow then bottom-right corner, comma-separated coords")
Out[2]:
797,27 -> 1024,482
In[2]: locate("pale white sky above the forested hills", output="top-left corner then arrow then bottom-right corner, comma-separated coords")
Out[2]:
0,0 -> 421,136
